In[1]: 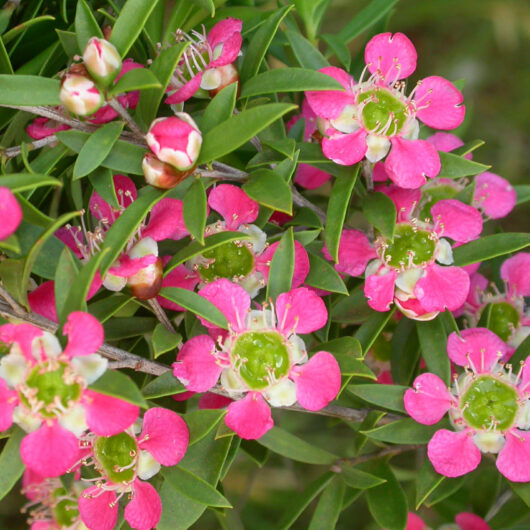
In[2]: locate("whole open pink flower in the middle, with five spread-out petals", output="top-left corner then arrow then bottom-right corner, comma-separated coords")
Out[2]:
173,279 -> 340,439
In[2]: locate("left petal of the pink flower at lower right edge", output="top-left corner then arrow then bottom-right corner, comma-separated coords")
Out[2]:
403,373 -> 452,425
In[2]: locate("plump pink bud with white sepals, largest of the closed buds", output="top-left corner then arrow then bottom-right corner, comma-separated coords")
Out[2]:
145,112 -> 202,171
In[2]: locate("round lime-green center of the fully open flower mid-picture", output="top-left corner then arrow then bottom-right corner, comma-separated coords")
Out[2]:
231,331 -> 290,390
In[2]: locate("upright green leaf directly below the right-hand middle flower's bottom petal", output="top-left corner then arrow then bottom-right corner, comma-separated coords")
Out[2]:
416,318 -> 451,385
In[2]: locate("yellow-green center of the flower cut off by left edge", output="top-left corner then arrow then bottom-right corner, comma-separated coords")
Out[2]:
20,361 -> 81,418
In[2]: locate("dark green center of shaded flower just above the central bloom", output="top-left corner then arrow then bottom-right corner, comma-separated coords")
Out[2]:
199,241 -> 254,282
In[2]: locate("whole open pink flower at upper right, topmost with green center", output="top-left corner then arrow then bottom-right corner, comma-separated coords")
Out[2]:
306,33 -> 465,188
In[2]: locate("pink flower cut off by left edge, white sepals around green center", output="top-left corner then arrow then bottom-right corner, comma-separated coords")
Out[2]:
0,312 -> 139,477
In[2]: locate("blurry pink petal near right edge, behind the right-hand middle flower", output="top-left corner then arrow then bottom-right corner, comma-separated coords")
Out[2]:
473,171 -> 517,219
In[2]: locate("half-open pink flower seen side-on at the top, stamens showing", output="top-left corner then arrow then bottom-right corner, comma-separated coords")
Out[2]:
166,18 -> 243,105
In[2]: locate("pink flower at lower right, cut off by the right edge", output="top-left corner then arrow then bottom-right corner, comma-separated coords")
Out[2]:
404,328 -> 530,482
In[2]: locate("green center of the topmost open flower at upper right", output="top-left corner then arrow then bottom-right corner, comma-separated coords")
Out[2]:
358,88 -> 407,136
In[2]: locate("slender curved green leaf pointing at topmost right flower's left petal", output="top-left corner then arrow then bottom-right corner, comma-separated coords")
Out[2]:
241,68 -> 344,97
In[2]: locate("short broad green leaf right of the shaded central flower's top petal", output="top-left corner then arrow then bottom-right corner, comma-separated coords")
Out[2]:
243,169 -> 293,214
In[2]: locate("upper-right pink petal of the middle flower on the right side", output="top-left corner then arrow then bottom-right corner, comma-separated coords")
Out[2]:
431,199 -> 482,243
